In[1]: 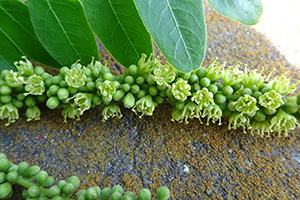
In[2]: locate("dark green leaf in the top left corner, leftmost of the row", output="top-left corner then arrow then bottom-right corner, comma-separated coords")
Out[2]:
0,0 -> 59,70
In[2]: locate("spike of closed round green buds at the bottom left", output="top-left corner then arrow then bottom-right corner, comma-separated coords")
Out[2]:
0,153 -> 170,200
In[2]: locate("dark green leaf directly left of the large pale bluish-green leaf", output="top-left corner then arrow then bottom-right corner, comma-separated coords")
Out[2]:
81,0 -> 153,67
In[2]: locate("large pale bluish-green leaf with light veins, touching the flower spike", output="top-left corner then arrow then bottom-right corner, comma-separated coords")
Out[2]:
134,0 -> 206,72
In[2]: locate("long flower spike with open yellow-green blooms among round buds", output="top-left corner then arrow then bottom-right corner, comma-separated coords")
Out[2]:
0,55 -> 300,136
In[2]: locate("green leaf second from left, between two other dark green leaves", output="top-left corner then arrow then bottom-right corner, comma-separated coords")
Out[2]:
27,0 -> 99,66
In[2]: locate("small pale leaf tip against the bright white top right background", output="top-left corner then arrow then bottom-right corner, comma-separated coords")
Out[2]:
208,0 -> 263,25
